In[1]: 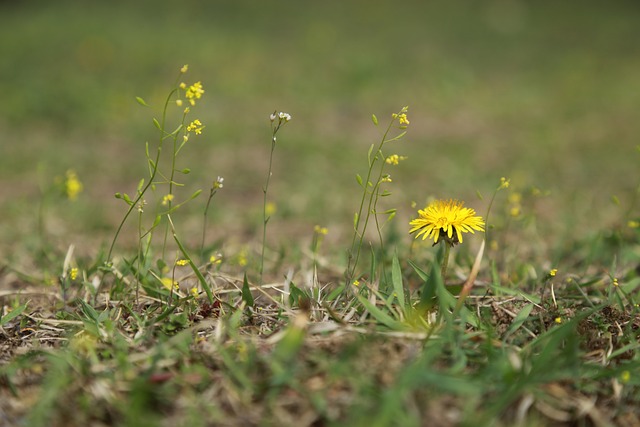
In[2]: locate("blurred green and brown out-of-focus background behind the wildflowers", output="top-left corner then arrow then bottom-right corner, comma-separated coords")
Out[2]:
0,0 -> 640,262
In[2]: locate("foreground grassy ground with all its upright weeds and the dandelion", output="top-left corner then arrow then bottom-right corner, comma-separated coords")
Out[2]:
0,66 -> 640,426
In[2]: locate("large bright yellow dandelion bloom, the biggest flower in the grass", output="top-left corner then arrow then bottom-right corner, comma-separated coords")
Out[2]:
409,200 -> 484,245
